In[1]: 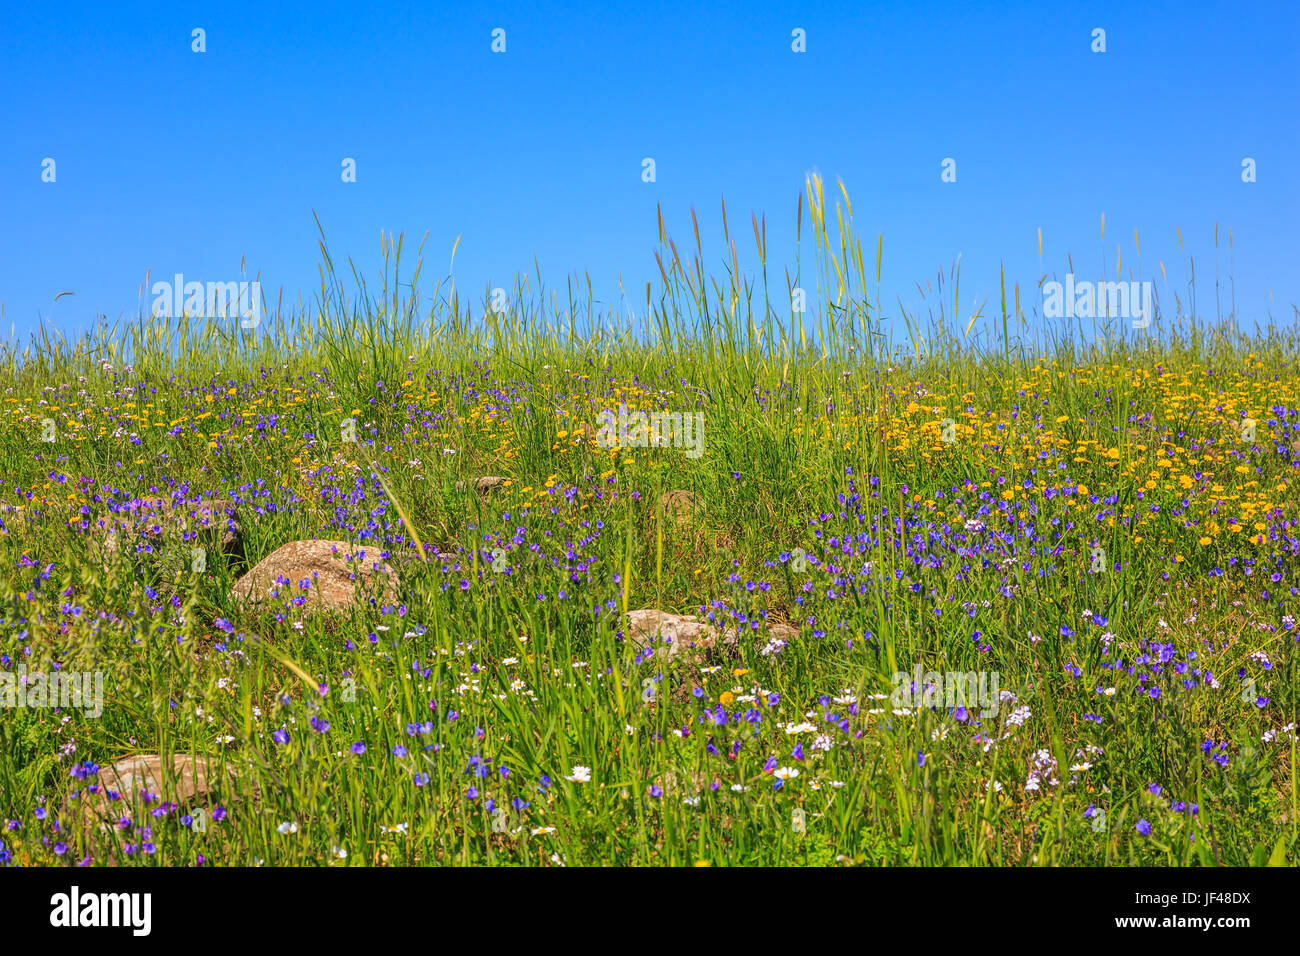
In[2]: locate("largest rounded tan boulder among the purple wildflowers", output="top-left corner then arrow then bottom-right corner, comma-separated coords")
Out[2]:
230,540 -> 398,610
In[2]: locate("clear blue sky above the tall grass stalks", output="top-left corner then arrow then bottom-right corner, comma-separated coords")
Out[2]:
0,0 -> 1300,348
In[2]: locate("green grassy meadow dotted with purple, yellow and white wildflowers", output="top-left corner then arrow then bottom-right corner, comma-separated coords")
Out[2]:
0,179 -> 1300,866
